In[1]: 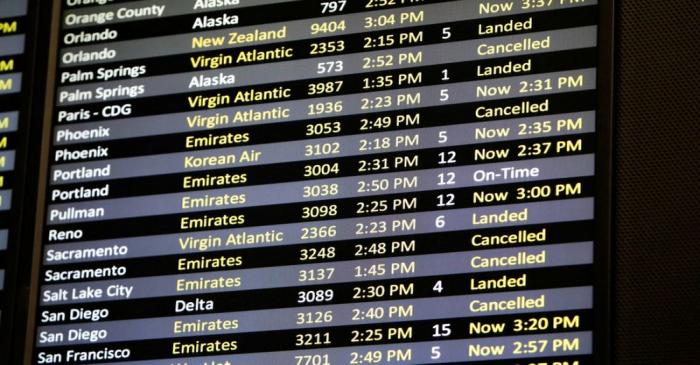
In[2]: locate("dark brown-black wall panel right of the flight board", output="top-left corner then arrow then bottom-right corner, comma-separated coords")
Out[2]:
612,0 -> 700,365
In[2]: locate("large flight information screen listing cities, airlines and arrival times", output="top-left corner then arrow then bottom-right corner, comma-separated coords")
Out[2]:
27,0 -> 609,365
